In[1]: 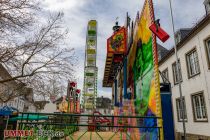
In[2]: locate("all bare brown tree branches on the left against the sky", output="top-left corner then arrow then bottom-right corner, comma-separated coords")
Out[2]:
0,0 -> 76,102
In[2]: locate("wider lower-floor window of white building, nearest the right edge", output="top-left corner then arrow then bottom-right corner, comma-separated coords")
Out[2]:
192,93 -> 207,121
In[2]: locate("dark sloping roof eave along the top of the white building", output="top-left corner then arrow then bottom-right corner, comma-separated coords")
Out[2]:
159,14 -> 210,65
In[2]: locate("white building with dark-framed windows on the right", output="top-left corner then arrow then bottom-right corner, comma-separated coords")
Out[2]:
159,0 -> 210,140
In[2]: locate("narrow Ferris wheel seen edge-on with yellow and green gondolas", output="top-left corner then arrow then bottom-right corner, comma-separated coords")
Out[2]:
82,20 -> 98,110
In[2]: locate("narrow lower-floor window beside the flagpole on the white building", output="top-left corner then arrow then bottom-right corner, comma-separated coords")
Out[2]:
176,98 -> 187,121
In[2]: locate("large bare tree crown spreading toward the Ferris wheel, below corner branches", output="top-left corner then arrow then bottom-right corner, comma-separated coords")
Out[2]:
0,13 -> 74,83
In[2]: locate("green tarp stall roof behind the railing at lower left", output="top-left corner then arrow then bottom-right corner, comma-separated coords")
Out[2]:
9,114 -> 48,121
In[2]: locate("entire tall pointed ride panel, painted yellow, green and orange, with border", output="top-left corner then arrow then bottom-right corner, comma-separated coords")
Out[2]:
111,0 -> 163,140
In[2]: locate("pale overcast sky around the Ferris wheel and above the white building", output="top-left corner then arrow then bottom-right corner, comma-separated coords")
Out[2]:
40,0 -> 205,97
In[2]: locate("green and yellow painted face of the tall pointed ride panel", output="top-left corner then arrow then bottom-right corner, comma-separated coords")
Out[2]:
133,0 -> 158,139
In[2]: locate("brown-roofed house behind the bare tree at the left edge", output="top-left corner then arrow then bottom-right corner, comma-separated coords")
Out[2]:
0,64 -> 37,112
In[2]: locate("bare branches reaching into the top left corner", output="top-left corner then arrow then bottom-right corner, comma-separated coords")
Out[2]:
0,0 -> 39,37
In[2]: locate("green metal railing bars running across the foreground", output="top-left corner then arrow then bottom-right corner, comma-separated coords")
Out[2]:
15,113 -> 161,140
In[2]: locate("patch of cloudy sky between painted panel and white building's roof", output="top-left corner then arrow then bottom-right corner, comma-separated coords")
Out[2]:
154,0 -> 205,49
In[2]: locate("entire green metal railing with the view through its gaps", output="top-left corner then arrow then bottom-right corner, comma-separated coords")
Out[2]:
12,113 -> 161,140
